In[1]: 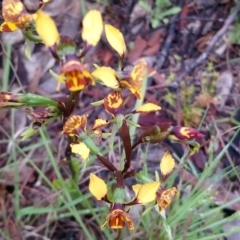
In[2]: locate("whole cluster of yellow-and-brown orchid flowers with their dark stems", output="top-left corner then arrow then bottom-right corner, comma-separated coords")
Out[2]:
0,0 -> 206,233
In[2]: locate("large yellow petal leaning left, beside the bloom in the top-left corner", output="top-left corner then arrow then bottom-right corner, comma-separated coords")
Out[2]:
36,9 -> 60,47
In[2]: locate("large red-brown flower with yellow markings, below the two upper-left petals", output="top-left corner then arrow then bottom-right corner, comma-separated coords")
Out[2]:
61,55 -> 94,92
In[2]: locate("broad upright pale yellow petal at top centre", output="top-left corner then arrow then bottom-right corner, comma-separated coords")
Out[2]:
82,10 -> 103,46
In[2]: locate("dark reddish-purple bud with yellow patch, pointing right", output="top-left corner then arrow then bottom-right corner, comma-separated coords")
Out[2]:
168,126 -> 204,141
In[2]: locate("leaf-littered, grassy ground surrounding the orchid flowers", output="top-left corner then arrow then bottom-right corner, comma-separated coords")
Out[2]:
0,0 -> 240,240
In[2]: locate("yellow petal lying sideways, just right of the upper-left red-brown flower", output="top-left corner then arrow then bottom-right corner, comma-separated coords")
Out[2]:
92,67 -> 119,89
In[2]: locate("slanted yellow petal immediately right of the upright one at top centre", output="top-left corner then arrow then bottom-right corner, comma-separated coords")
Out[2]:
105,24 -> 126,56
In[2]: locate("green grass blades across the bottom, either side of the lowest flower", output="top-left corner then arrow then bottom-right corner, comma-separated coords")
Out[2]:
0,77 -> 240,240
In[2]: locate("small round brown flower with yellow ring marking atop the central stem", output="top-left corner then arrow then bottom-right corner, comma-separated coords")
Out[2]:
104,92 -> 123,117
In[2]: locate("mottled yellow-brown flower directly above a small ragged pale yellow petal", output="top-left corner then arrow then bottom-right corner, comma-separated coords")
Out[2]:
62,115 -> 87,136
